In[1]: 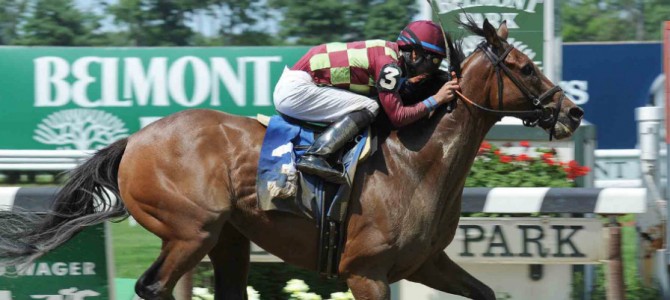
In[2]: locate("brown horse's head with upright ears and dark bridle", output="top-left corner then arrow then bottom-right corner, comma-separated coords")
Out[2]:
460,19 -> 584,139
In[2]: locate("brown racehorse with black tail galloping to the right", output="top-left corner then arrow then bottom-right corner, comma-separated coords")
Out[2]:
0,20 -> 583,299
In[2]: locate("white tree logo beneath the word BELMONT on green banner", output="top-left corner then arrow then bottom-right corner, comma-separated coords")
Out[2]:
33,109 -> 128,150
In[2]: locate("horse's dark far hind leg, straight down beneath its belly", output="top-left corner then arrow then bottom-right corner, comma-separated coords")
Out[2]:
209,223 -> 250,300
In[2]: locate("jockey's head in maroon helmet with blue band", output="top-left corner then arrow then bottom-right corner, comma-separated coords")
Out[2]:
397,21 -> 447,77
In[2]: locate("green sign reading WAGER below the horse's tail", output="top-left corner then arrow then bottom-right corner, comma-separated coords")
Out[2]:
0,224 -> 112,300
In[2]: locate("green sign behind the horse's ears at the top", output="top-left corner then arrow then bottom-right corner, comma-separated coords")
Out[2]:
435,0 -> 545,68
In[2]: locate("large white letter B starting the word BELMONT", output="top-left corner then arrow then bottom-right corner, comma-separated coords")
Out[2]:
34,56 -> 70,107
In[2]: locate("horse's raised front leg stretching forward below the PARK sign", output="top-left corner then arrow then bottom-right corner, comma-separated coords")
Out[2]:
406,251 -> 496,300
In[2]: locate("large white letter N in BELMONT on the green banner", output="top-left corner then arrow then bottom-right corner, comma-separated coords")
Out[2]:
210,57 -> 247,106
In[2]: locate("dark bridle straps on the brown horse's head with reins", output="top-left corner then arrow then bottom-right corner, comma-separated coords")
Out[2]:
457,41 -> 565,138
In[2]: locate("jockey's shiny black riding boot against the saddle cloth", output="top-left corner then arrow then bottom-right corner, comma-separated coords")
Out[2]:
296,109 -> 375,184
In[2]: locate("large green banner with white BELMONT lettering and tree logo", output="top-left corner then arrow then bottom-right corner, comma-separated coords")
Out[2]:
0,47 -> 308,150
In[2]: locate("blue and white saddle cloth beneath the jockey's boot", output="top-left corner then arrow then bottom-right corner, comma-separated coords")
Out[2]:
256,115 -> 373,224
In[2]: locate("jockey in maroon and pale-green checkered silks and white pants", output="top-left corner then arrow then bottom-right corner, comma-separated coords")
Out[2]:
274,21 -> 459,183
